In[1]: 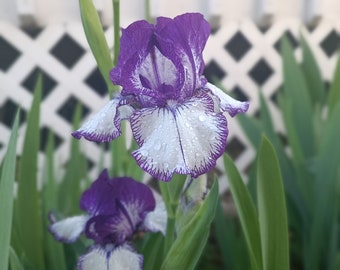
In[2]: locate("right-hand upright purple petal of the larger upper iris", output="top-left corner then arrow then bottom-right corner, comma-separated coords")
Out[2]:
156,13 -> 210,99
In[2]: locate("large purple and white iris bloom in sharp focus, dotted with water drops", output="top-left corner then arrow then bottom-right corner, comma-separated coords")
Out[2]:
72,13 -> 249,181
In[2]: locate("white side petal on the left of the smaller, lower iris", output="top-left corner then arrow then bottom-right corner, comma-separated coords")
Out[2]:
49,215 -> 89,243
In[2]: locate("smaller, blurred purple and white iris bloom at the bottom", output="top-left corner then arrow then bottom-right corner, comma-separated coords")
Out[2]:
49,170 -> 167,270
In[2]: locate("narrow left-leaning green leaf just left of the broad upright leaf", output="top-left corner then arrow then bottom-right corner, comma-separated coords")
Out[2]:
224,155 -> 262,270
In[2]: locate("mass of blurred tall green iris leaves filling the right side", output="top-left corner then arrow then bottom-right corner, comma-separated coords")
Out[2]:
239,34 -> 340,269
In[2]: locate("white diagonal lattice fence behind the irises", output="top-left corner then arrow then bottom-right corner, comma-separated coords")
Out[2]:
0,19 -> 340,191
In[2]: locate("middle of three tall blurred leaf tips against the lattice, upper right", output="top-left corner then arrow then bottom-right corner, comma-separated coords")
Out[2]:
300,33 -> 325,106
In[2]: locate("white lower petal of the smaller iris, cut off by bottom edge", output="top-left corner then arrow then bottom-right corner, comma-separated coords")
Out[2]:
78,245 -> 143,270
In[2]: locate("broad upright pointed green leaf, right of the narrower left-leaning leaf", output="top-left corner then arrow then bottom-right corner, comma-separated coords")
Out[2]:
257,137 -> 289,270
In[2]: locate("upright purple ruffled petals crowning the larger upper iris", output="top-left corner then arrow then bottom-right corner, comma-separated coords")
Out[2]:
110,13 -> 210,107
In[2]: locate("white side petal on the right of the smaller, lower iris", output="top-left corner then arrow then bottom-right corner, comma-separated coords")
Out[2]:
143,201 -> 167,235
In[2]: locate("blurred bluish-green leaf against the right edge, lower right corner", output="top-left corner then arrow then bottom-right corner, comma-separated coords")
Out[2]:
307,103 -> 340,269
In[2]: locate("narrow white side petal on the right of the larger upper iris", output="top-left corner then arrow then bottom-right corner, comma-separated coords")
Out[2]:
206,83 -> 249,116
